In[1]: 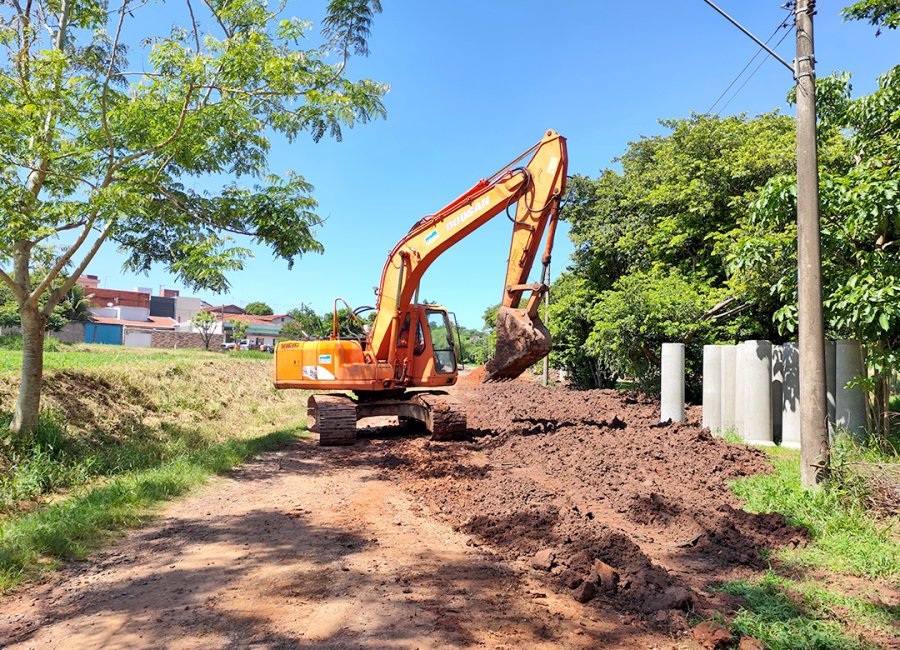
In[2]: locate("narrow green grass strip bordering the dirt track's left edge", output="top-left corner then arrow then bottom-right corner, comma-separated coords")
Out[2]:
0,422 -> 300,591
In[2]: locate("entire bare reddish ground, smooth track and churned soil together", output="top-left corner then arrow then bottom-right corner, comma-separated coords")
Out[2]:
0,382 -> 805,648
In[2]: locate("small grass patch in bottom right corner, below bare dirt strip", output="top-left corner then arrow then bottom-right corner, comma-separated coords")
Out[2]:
721,571 -> 900,650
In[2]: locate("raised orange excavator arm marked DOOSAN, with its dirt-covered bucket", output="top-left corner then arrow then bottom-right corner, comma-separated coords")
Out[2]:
368,131 -> 568,379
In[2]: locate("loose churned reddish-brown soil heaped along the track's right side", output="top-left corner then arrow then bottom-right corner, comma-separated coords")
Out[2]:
376,382 -> 805,628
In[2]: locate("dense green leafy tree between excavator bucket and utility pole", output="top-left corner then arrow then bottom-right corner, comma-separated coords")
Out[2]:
550,112 -> 847,389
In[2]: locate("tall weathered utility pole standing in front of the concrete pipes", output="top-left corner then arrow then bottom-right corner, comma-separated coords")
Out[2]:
794,0 -> 829,488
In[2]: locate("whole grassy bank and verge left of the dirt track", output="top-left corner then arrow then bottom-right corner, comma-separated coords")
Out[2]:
0,344 -> 306,591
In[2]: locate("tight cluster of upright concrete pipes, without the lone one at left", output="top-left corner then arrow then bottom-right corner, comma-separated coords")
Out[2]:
700,341 -> 866,449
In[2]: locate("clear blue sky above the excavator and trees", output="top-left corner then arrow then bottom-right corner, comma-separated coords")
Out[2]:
81,0 -> 900,327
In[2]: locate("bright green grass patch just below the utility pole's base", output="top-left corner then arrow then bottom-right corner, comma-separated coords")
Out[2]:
732,448 -> 900,578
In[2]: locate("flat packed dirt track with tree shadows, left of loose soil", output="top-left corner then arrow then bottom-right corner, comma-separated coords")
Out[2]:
0,430 -> 669,648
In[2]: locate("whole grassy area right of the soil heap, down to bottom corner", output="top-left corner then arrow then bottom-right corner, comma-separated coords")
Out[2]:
720,438 -> 900,650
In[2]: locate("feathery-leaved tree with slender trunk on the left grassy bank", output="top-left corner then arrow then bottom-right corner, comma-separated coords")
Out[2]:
0,0 -> 387,434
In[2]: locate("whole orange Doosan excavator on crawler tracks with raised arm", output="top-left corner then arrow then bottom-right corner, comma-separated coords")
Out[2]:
275,131 -> 568,445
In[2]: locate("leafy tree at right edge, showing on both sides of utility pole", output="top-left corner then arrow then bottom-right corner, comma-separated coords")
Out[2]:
732,65 -> 900,437
